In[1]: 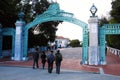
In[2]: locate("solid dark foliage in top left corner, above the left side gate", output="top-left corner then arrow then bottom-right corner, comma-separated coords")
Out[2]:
0,0 -> 20,27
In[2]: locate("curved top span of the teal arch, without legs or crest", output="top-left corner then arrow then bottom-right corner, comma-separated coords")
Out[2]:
25,16 -> 87,30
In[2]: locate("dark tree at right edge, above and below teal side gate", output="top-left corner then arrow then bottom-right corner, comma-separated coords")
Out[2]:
108,0 -> 120,49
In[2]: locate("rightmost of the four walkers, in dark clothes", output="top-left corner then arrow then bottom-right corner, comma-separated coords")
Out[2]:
55,50 -> 62,74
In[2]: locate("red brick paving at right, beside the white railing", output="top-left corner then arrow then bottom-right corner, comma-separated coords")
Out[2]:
102,51 -> 120,76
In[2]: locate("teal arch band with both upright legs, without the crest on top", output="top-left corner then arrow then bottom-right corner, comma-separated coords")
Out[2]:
23,16 -> 88,63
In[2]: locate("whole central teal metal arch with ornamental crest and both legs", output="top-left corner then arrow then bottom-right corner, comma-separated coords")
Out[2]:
23,3 -> 88,63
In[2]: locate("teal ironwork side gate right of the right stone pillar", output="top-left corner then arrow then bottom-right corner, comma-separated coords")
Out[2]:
99,24 -> 120,63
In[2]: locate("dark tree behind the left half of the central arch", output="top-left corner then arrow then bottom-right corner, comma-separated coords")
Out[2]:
19,0 -> 60,47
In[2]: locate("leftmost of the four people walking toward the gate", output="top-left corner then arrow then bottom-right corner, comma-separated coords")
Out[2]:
33,48 -> 39,69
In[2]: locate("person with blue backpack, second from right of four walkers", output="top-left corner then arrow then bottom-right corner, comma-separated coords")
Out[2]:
47,51 -> 55,73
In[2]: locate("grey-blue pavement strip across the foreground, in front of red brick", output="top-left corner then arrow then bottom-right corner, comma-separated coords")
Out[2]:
0,66 -> 120,80
